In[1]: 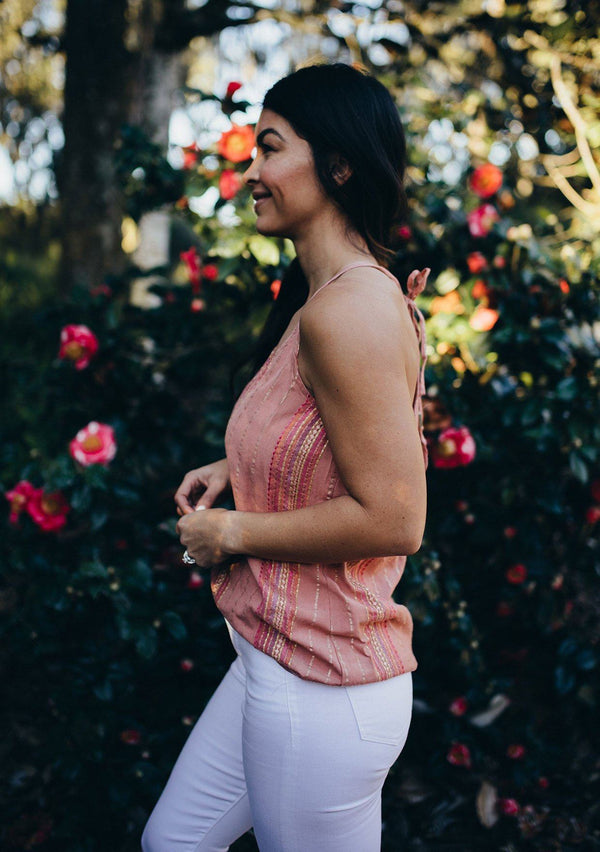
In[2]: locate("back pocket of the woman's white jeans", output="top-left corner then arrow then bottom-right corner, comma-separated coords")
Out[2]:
345,672 -> 412,748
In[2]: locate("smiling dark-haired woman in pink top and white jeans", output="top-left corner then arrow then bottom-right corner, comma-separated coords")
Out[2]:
142,64 -> 428,852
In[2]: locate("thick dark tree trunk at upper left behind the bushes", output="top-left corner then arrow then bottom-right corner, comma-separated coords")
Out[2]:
58,0 -> 129,292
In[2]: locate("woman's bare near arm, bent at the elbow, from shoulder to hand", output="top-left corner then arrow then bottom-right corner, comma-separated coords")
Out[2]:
180,281 -> 426,565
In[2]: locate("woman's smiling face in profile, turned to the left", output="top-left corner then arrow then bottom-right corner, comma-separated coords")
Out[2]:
244,109 -> 331,240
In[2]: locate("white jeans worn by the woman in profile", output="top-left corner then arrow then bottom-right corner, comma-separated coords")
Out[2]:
142,624 -> 412,852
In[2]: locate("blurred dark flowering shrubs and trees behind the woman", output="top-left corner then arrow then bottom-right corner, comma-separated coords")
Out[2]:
0,0 -> 600,852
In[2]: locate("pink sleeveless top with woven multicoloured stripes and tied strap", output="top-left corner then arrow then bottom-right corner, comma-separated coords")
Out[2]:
211,262 -> 428,686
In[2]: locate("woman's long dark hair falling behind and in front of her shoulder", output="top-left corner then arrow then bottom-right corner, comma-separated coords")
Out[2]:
247,63 -> 408,382
